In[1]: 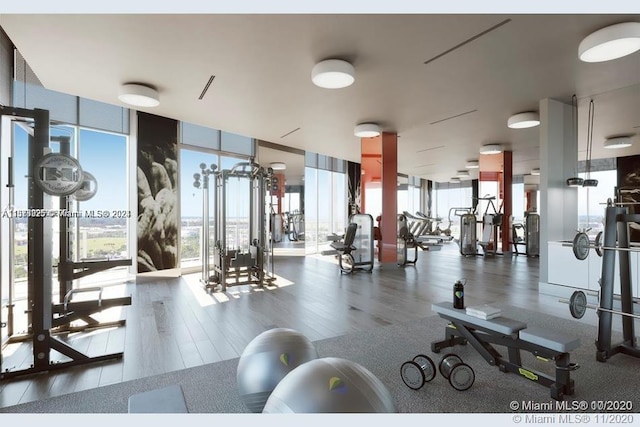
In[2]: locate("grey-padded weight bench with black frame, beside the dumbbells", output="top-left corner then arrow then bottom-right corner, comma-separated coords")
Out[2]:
431,302 -> 580,400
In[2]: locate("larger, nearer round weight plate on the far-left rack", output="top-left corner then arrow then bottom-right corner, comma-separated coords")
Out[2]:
33,153 -> 83,196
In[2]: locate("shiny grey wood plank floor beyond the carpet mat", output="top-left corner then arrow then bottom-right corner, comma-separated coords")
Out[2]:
0,243 -> 592,407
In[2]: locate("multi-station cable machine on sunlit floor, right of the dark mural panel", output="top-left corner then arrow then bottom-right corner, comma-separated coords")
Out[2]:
194,161 -> 275,292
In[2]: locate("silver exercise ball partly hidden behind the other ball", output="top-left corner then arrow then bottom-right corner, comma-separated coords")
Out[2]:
236,328 -> 318,412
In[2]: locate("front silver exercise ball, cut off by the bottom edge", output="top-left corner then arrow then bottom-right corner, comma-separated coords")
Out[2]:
262,357 -> 396,413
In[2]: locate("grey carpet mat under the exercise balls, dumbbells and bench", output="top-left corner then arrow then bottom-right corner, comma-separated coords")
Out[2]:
0,307 -> 640,413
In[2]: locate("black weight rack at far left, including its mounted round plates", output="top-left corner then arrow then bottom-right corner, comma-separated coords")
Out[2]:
0,106 -> 131,380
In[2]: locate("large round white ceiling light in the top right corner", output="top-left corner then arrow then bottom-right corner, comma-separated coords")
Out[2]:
578,22 -> 640,62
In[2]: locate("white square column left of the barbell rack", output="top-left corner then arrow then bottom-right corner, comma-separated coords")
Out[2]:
540,98 -> 578,283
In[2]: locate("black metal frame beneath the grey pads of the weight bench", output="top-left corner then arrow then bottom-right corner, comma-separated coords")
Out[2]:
431,313 -> 577,400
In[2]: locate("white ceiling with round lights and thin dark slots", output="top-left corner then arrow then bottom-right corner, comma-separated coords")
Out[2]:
0,14 -> 640,181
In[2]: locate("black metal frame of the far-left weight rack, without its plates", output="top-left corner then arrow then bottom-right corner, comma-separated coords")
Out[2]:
0,106 -> 131,380
